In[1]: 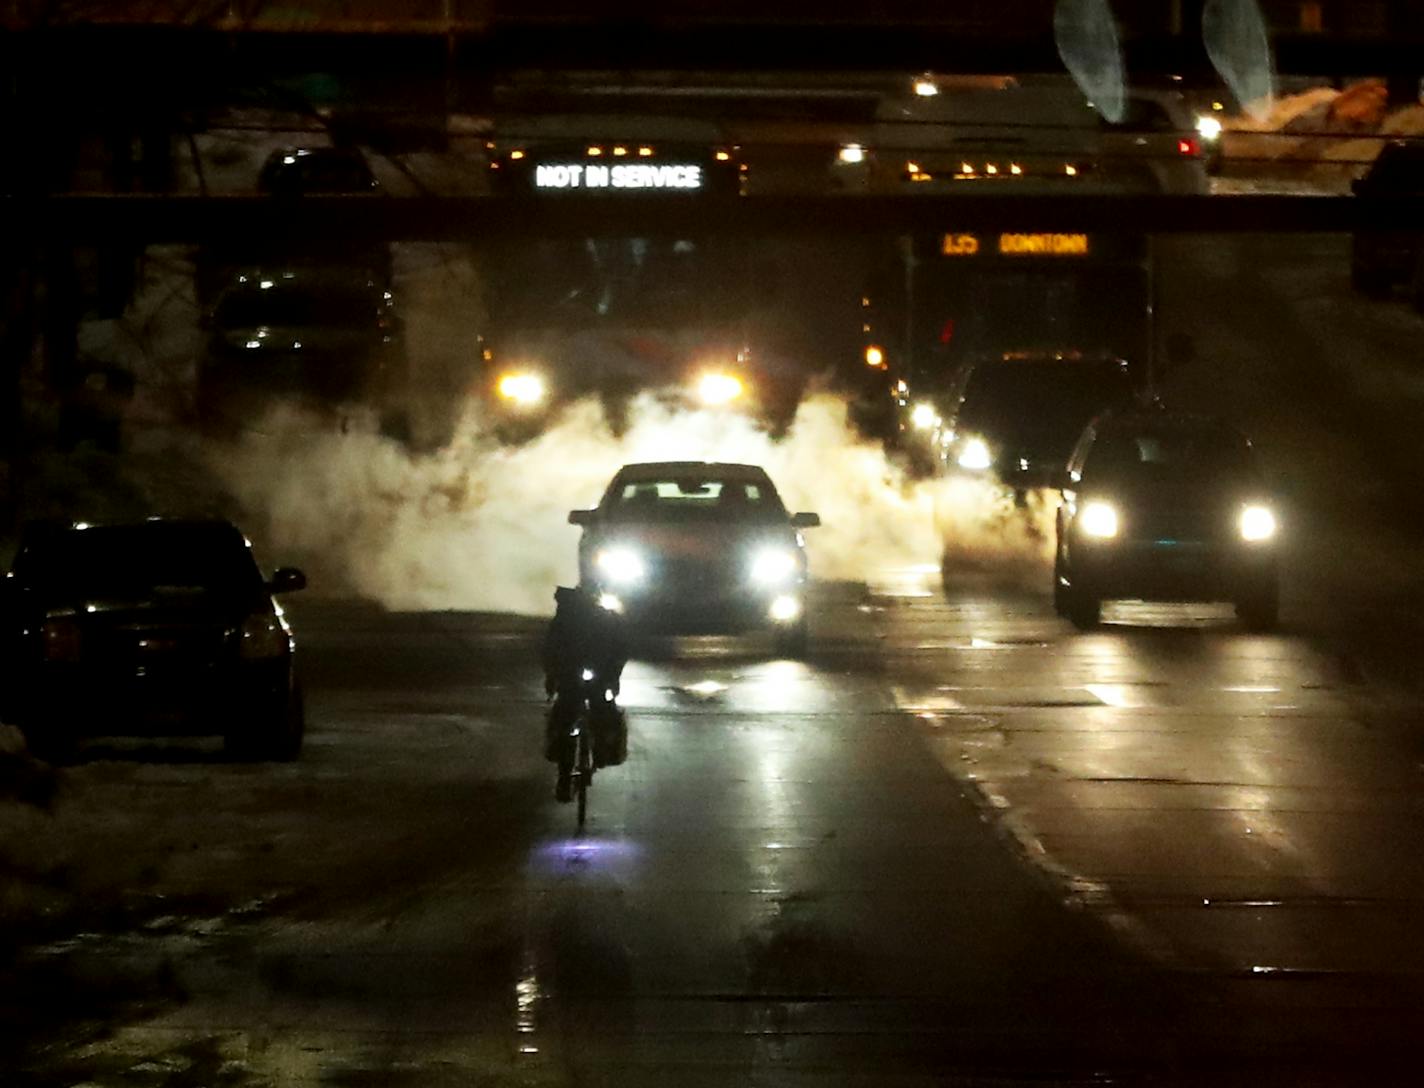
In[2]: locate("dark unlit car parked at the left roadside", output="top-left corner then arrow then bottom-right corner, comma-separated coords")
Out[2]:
0,518 -> 306,760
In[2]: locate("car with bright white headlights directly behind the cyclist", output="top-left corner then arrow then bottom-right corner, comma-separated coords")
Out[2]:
568,461 -> 820,657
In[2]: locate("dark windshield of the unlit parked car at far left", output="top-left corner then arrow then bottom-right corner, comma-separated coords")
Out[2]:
14,525 -> 262,600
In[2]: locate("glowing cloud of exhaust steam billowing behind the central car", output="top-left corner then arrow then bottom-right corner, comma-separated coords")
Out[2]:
209,393 -> 1052,614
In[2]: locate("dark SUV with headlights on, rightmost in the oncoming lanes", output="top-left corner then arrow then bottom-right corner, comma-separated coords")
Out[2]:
1054,409 -> 1279,629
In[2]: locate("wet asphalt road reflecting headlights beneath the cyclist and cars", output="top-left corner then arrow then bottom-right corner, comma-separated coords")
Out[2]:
6,563 -> 1424,1085
